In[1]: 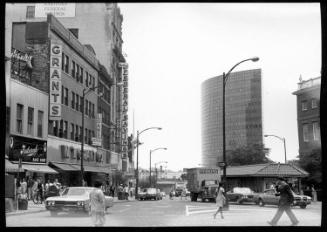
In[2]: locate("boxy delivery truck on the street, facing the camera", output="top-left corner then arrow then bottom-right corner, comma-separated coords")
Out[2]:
186,167 -> 221,202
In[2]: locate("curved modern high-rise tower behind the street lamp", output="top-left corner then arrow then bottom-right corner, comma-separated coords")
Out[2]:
201,69 -> 262,166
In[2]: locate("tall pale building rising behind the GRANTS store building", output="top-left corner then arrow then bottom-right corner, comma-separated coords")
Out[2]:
7,3 -> 134,185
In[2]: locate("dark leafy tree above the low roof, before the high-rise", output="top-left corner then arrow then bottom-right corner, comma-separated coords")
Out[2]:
226,144 -> 273,166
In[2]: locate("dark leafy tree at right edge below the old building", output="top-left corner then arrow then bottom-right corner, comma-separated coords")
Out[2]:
299,148 -> 322,187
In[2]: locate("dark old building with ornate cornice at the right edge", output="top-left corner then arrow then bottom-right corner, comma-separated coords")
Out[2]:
293,77 -> 321,158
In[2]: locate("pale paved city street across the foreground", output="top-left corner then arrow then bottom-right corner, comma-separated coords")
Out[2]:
6,197 -> 321,227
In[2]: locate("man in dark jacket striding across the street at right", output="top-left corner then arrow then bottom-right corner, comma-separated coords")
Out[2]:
268,178 -> 299,226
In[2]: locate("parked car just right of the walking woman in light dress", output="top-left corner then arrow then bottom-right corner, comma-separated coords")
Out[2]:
227,187 -> 256,204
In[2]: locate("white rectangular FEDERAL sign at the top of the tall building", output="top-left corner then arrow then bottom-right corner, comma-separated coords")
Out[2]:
35,3 -> 75,18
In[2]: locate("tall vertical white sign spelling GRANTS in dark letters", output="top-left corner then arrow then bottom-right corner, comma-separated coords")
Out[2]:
49,41 -> 62,120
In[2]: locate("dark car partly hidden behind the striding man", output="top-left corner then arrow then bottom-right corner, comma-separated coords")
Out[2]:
255,189 -> 311,209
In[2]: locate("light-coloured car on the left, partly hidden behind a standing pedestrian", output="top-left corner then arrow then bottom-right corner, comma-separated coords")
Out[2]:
45,187 -> 114,216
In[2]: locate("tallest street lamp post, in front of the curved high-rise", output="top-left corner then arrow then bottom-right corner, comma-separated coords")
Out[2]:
222,57 -> 259,189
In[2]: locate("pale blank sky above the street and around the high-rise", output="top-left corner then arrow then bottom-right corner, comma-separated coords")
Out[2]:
118,3 -> 321,171
